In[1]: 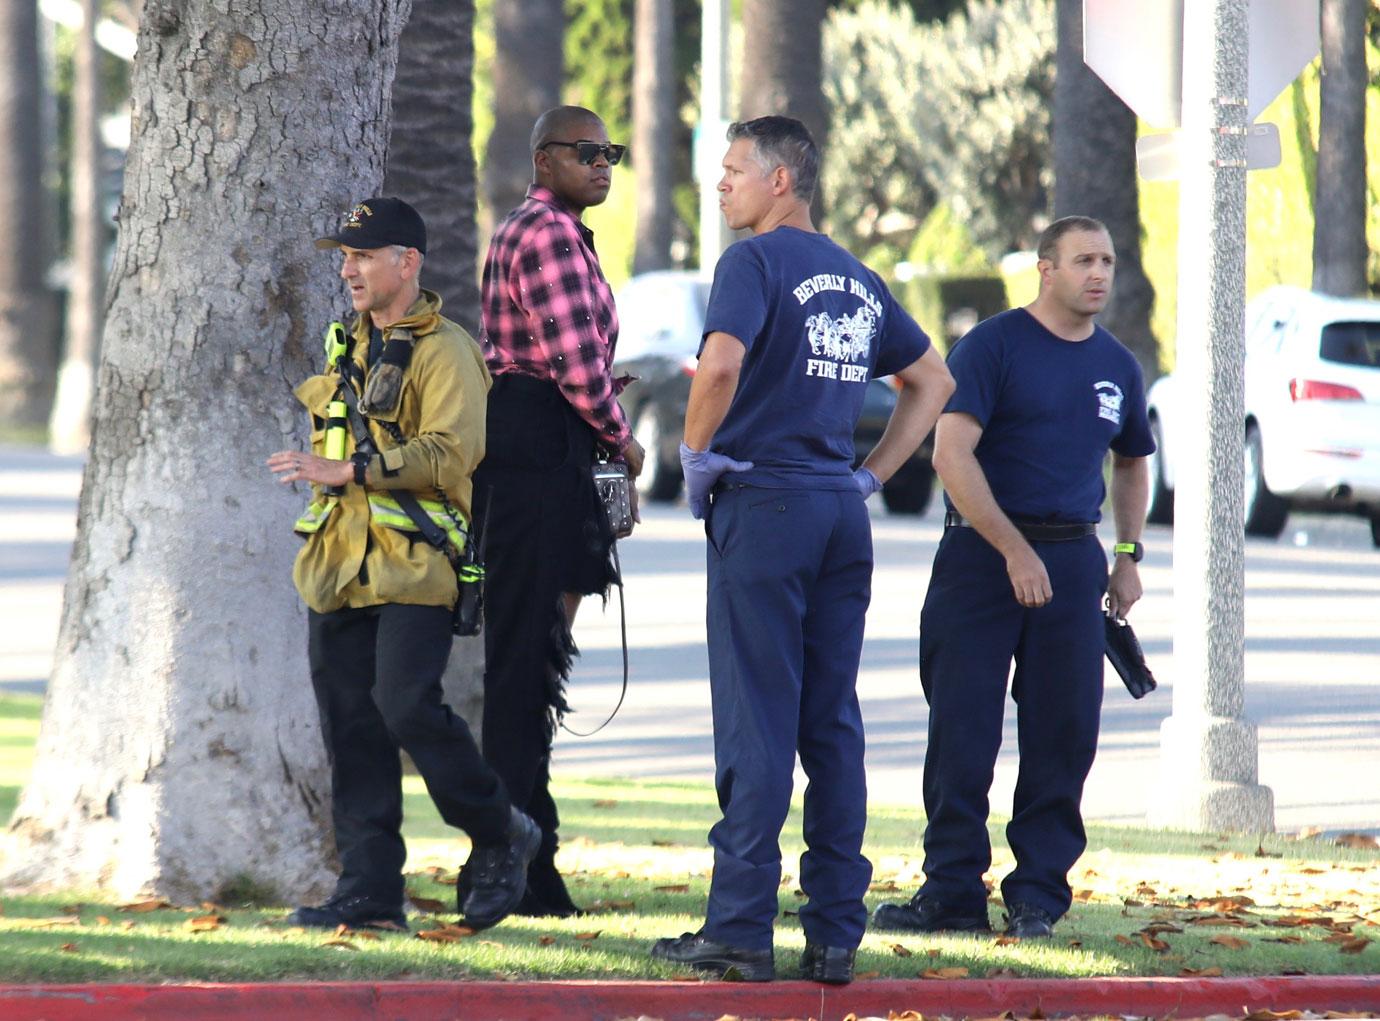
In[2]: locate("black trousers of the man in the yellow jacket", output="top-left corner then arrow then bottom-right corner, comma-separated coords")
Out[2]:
308,604 -> 509,904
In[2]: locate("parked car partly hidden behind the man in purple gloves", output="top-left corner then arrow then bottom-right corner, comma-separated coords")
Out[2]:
614,270 -> 934,515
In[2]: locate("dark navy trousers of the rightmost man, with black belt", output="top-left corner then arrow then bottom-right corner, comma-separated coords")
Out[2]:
920,527 -> 1107,919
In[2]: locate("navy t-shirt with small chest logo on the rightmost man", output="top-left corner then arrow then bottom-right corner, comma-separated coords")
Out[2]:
944,309 -> 1155,522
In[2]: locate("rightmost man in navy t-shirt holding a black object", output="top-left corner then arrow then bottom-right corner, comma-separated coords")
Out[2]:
874,217 -> 1155,937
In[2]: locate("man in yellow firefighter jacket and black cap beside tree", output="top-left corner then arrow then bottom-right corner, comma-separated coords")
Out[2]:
268,199 -> 541,929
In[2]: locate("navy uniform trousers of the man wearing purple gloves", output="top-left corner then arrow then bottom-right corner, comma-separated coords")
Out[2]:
704,486 -> 872,949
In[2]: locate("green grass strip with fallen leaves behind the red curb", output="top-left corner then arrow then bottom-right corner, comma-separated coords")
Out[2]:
0,697 -> 1380,981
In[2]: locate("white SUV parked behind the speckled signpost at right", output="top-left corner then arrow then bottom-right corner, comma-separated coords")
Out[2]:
1148,287 -> 1380,546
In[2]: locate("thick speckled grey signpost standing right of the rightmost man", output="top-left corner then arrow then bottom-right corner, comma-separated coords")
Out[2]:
1151,0 -> 1274,832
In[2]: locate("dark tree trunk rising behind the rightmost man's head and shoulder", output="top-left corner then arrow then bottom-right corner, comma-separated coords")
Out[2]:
1053,0 -> 1159,382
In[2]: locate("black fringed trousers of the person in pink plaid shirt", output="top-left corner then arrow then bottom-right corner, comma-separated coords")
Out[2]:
475,375 -> 613,865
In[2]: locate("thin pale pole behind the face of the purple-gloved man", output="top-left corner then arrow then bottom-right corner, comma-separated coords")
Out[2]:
694,0 -> 733,273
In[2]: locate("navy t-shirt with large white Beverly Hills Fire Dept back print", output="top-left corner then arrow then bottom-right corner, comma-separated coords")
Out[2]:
701,226 -> 930,490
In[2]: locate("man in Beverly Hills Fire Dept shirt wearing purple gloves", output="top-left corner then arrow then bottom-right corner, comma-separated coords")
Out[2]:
653,117 -> 954,984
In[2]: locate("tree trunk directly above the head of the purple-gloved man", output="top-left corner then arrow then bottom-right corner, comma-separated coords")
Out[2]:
740,0 -> 829,217
